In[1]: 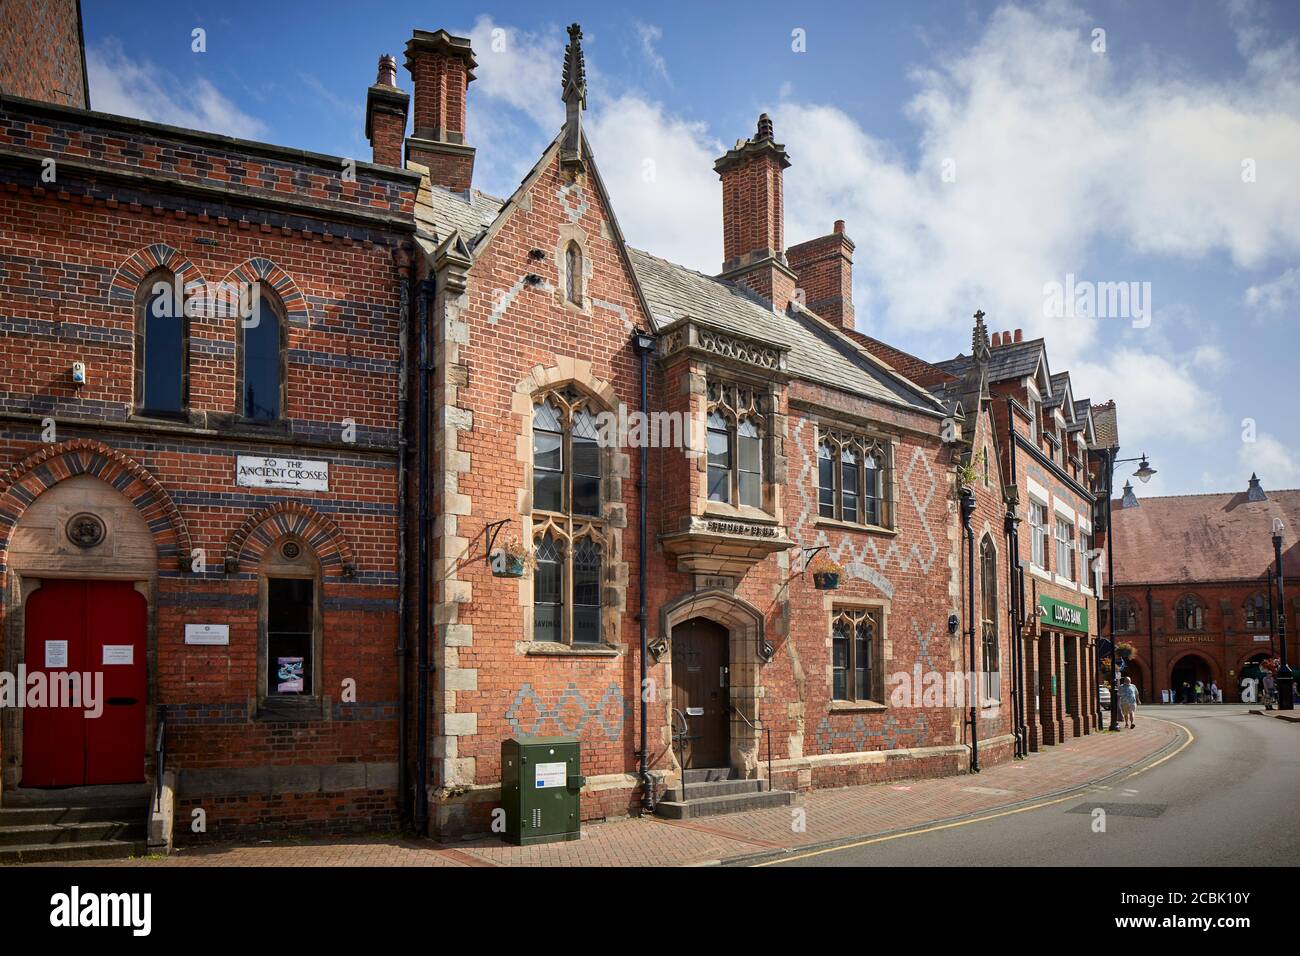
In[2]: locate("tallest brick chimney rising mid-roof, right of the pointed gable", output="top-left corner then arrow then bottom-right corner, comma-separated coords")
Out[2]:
714,113 -> 796,310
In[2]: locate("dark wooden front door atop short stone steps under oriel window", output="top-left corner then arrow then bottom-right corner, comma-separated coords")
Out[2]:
672,618 -> 731,767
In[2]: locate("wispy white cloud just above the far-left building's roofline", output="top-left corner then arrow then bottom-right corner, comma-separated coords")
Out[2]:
86,39 -> 267,139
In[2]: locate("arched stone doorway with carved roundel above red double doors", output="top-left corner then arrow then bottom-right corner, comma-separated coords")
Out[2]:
0,473 -> 159,790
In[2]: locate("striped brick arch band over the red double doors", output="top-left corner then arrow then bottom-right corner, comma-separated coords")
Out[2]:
0,438 -> 191,571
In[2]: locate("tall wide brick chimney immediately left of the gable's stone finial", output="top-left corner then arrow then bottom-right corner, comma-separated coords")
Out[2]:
406,30 -> 478,193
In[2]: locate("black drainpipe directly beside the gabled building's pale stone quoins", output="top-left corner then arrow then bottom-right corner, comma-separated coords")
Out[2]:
415,278 -> 434,835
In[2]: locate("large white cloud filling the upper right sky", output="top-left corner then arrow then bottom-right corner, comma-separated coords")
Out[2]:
775,3 -> 1300,343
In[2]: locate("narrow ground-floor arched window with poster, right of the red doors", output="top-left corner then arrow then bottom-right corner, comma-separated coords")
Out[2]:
257,536 -> 322,717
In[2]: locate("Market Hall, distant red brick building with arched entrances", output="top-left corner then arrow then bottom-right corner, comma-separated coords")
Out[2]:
1104,475 -> 1300,702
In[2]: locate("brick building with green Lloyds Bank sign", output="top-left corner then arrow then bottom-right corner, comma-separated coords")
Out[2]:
937,329 -> 1114,750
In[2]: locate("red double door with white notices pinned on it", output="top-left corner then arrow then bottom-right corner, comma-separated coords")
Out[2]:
22,579 -> 147,787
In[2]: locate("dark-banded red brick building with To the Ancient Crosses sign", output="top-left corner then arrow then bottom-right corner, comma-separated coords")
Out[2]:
0,3 -> 419,853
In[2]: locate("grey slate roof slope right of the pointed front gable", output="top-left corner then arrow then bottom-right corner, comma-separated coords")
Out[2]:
628,246 -> 939,412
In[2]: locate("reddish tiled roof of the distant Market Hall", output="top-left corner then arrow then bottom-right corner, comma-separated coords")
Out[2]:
1112,489 -> 1300,585
